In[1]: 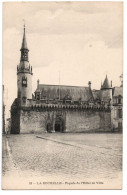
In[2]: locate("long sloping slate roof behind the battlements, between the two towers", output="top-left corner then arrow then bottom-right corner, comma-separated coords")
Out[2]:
35,84 -> 93,101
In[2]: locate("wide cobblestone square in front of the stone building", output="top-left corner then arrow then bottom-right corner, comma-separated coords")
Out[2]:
2,133 -> 122,189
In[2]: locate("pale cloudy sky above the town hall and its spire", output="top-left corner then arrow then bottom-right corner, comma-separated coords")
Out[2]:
3,2 -> 123,116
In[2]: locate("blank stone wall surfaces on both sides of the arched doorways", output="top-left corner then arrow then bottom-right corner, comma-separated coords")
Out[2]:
20,107 -> 111,133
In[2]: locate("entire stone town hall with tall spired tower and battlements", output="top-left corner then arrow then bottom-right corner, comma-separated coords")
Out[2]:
11,27 -> 122,134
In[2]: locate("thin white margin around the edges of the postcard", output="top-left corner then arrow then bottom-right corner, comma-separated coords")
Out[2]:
0,0 -> 127,195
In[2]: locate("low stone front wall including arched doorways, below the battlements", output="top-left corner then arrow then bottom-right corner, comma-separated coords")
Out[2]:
12,105 -> 112,133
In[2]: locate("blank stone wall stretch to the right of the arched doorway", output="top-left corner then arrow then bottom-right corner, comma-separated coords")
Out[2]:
66,111 -> 111,132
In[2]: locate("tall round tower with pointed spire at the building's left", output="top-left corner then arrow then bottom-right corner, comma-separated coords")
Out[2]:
17,25 -> 33,105
